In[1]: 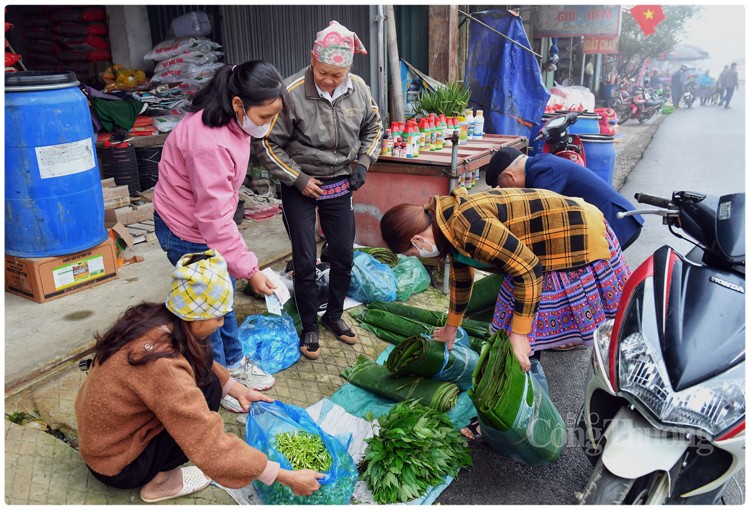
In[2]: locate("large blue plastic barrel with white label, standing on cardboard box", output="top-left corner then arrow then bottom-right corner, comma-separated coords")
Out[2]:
5,71 -> 107,257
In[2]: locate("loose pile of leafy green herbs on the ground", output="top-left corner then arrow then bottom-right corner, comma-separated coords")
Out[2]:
360,401 -> 472,504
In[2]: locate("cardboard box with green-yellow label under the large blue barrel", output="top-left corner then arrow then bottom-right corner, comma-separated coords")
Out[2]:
5,237 -> 117,303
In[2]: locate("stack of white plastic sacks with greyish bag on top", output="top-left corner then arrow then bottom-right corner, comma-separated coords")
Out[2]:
143,12 -> 224,93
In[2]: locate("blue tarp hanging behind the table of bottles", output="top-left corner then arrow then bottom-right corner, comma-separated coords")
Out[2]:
466,10 -> 550,138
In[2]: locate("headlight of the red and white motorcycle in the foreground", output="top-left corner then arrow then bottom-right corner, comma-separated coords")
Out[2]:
617,279 -> 745,437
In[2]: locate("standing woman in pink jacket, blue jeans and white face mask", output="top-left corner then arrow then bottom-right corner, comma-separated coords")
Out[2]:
154,60 -> 284,412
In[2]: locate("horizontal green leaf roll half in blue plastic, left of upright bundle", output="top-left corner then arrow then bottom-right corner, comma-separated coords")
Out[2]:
385,336 -> 479,390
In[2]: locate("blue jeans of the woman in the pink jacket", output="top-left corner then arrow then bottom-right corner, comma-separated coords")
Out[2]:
154,211 -> 244,367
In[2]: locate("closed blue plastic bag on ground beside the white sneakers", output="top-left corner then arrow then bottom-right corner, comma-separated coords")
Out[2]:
238,312 -> 299,374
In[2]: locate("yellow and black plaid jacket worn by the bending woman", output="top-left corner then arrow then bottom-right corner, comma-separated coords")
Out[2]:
436,188 -> 610,334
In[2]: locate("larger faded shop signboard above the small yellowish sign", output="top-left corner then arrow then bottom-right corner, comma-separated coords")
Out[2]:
534,5 -> 622,37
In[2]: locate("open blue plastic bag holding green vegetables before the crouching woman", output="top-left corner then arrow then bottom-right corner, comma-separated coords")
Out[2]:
245,400 -> 359,505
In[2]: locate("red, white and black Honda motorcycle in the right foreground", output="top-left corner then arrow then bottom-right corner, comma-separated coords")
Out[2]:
578,191 -> 745,504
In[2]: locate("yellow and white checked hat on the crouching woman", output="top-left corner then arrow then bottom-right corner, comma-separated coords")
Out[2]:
166,250 -> 234,321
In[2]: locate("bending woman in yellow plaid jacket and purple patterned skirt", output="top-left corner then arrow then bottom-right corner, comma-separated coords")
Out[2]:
380,188 -> 630,371
